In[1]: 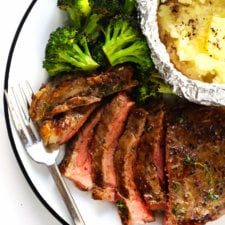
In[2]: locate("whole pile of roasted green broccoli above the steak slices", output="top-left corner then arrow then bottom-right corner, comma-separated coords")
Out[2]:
43,0 -> 152,75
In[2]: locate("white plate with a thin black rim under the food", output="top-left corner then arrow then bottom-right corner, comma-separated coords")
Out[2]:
2,0 -> 225,225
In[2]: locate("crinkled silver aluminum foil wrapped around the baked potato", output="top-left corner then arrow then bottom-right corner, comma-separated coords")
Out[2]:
137,0 -> 225,106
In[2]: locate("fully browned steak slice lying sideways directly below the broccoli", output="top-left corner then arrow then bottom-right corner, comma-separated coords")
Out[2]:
30,66 -> 137,121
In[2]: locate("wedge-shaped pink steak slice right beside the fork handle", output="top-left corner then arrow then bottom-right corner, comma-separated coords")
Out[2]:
59,106 -> 103,191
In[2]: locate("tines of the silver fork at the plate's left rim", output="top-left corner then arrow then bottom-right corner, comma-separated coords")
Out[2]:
4,82 -> 40,146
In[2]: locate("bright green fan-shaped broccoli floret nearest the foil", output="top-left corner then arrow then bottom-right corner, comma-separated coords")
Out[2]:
103,18 -> 152,71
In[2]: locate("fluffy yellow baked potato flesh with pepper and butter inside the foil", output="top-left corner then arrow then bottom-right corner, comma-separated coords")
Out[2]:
158,0 -> 225,83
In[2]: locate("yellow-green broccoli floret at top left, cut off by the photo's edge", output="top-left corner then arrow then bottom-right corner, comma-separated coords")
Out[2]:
57,0 -> 91,29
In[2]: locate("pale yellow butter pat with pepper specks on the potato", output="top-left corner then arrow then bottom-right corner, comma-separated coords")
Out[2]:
207,16 -> 225,60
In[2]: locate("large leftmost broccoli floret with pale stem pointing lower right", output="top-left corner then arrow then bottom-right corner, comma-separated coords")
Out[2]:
43,27 -> 99,75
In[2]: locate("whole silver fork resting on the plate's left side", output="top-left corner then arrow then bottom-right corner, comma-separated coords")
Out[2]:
4,82 -> 85,225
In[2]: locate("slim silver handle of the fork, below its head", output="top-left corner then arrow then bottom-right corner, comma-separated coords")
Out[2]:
48,163 -> 85,225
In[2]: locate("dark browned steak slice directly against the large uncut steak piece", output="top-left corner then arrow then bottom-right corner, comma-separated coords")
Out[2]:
135,98 -> 166,210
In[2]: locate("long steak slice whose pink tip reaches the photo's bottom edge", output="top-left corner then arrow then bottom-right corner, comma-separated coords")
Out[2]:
114,108 -> 154,225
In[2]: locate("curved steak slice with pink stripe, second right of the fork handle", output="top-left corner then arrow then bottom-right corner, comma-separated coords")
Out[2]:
92,93 -> 134,201
